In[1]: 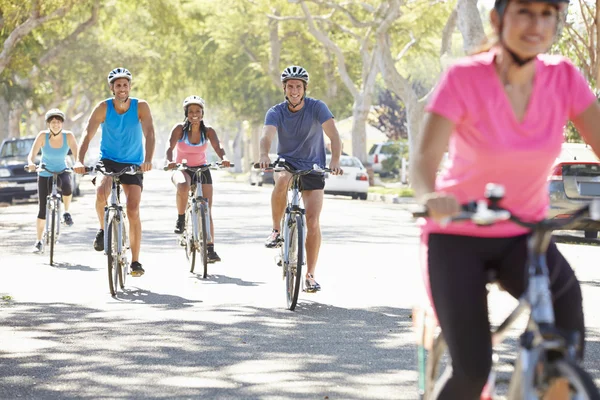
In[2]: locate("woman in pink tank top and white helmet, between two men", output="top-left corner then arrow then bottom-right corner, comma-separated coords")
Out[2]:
165,96 -> 230,263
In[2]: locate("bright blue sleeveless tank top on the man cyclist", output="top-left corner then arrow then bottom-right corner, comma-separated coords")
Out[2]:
100,97 -> 144,165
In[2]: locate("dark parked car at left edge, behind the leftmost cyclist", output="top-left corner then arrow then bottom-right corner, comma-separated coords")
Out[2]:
0,137 -> 81,203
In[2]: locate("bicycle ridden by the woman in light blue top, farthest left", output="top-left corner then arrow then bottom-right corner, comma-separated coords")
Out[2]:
25,164 -> 72,266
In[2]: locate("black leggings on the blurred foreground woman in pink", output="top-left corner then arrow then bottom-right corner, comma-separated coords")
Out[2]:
427,234 -> 585,400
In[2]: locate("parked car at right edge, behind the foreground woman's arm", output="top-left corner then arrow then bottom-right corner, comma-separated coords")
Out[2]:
548,143 -> 600,239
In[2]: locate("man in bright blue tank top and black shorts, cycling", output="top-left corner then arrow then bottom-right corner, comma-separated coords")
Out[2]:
74,68 -> 154,276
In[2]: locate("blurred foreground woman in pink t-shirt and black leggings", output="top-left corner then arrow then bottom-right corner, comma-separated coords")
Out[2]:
411,0 -> 600,400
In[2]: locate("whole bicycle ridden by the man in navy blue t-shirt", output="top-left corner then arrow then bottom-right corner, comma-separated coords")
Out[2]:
254,158 -> 333,311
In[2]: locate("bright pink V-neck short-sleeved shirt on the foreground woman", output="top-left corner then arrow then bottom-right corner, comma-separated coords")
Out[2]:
422,49 -> 596,240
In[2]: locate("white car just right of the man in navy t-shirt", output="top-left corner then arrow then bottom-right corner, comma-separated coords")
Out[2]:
325,155 -> 369,200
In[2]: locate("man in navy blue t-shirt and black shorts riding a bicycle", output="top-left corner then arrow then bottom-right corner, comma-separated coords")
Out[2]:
259,65 -> 343,292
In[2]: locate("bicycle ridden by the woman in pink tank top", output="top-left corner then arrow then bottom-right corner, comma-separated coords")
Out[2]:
164,160 -> 234,278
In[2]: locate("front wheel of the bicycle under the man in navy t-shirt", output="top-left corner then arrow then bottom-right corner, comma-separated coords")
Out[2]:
283,215 -> 304,311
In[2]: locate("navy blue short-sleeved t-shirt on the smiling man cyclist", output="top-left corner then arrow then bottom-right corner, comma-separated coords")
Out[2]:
265,97 -> 333,169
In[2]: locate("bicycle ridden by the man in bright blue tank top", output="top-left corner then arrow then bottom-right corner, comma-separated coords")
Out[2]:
86,164 -> 143,296
